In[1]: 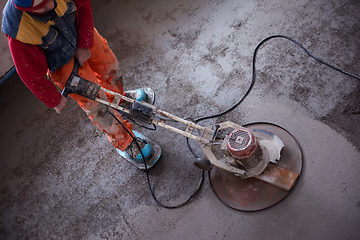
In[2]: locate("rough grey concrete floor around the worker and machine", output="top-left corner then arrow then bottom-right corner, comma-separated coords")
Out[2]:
0,0 -> 360,240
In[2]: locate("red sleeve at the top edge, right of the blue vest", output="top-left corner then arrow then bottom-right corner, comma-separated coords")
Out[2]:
73,0 -> 94,49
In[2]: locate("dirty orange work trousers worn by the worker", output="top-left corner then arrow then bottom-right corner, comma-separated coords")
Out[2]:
49,29 -> 133,151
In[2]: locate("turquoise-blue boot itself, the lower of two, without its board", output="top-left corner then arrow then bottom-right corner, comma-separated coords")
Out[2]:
124,131 -> 153,163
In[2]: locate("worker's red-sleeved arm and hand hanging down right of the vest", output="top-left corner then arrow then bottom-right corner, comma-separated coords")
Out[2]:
74,0 -> 94,66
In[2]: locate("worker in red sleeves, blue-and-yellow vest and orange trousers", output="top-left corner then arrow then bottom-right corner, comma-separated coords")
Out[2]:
2,0 -> 153,165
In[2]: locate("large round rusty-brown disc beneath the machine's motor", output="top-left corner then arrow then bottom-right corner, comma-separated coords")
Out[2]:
210,123 -> 302,211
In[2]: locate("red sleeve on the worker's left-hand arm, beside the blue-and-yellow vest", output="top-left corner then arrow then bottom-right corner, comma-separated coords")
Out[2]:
7,36 -> 61,108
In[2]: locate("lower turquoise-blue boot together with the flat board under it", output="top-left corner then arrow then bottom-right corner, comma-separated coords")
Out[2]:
116,131 -> 161,170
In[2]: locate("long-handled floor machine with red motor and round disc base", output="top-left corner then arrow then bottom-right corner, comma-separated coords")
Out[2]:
63,69 -> 302,211
